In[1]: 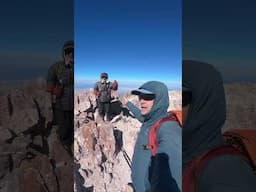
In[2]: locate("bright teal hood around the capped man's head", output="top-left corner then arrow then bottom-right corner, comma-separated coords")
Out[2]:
140,81 -> 169,120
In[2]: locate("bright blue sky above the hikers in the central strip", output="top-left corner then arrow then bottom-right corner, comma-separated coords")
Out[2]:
75,0 -> 182,84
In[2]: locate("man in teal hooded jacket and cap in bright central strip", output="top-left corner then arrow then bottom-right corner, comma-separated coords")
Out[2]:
122,81 -> 182,192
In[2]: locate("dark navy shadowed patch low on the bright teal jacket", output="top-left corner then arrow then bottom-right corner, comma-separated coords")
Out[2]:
148,153 -> 180,192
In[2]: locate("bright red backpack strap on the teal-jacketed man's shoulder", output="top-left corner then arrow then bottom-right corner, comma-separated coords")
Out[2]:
145,116 -> 178,156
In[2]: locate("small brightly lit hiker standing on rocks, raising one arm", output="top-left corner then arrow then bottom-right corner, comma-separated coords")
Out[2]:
94,73 -> 118,121
